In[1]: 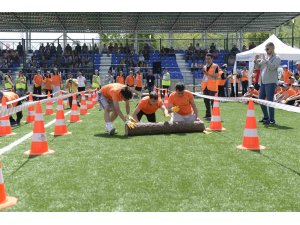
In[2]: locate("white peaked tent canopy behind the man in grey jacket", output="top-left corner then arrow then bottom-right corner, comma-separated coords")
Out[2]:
236,34 -> 300,61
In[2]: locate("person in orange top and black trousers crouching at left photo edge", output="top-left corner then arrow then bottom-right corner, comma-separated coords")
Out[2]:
0,91 -> 23,127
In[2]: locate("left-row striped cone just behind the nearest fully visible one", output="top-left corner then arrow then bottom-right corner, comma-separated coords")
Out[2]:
51,99 -> 71,136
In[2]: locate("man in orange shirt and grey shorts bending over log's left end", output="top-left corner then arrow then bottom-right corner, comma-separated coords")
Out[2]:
98,83 -> 136,135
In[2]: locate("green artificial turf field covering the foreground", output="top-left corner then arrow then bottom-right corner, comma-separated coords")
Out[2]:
0,99 -> 300,212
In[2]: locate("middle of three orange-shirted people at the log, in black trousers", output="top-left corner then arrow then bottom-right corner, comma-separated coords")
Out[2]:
132,92 -> 170,123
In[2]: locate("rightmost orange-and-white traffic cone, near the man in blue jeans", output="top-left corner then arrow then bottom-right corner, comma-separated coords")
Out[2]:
237,99 -> 265,151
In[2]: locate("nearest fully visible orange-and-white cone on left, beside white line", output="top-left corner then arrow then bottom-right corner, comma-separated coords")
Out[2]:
24,102 -> 54,156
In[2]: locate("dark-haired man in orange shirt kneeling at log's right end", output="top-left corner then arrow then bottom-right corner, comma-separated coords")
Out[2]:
168,83 -> 200,123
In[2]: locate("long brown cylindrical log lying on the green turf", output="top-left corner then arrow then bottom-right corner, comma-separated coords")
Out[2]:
125,121 -> 205,136
